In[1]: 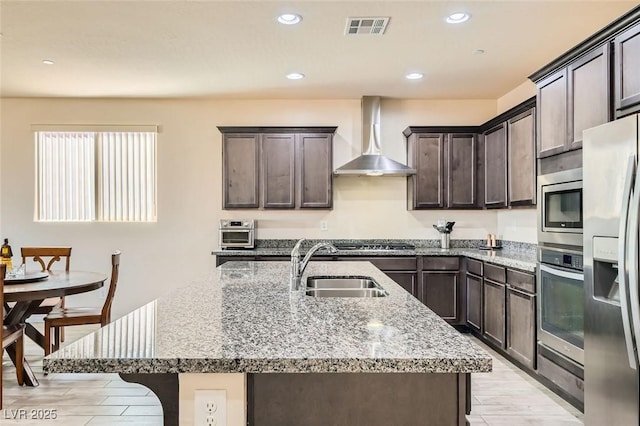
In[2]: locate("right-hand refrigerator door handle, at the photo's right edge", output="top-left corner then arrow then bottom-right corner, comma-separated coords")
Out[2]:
627,157 -> 640,366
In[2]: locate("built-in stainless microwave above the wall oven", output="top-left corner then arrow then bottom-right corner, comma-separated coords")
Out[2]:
538,168 -> 584,247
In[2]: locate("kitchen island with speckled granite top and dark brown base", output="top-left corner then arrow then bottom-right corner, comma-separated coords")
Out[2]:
43,262 -> 491,425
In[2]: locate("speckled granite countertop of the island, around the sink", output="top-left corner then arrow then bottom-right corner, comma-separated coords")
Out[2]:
43,261 -> 491,373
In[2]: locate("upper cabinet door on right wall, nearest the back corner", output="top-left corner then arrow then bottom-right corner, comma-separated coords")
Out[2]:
484,124 -> 507,208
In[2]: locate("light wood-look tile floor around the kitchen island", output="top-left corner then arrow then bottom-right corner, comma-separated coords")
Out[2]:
0,326 -> 582,426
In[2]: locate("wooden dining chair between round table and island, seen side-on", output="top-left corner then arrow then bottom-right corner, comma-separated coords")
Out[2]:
44,251 -> 120,355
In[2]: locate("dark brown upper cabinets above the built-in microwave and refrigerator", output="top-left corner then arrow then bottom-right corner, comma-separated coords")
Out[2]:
529,6 -> 640,161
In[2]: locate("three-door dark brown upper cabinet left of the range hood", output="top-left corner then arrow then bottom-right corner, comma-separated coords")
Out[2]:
218,127 -> 336,209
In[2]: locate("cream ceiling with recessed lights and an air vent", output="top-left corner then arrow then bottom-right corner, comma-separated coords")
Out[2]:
0,0 -> 638,99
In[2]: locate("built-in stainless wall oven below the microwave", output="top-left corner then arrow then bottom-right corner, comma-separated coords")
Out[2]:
538,247 -> 584,365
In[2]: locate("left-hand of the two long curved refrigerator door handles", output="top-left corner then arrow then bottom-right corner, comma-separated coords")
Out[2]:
618,155 -> 637,370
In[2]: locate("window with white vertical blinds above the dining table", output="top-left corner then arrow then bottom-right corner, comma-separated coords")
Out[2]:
35,126 -> 157,222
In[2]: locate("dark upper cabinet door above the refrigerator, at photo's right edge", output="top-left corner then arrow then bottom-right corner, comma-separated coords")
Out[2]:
614,25 -> 640,116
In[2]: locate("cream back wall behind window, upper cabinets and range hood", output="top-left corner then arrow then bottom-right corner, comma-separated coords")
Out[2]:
0,99 -> 497,317
